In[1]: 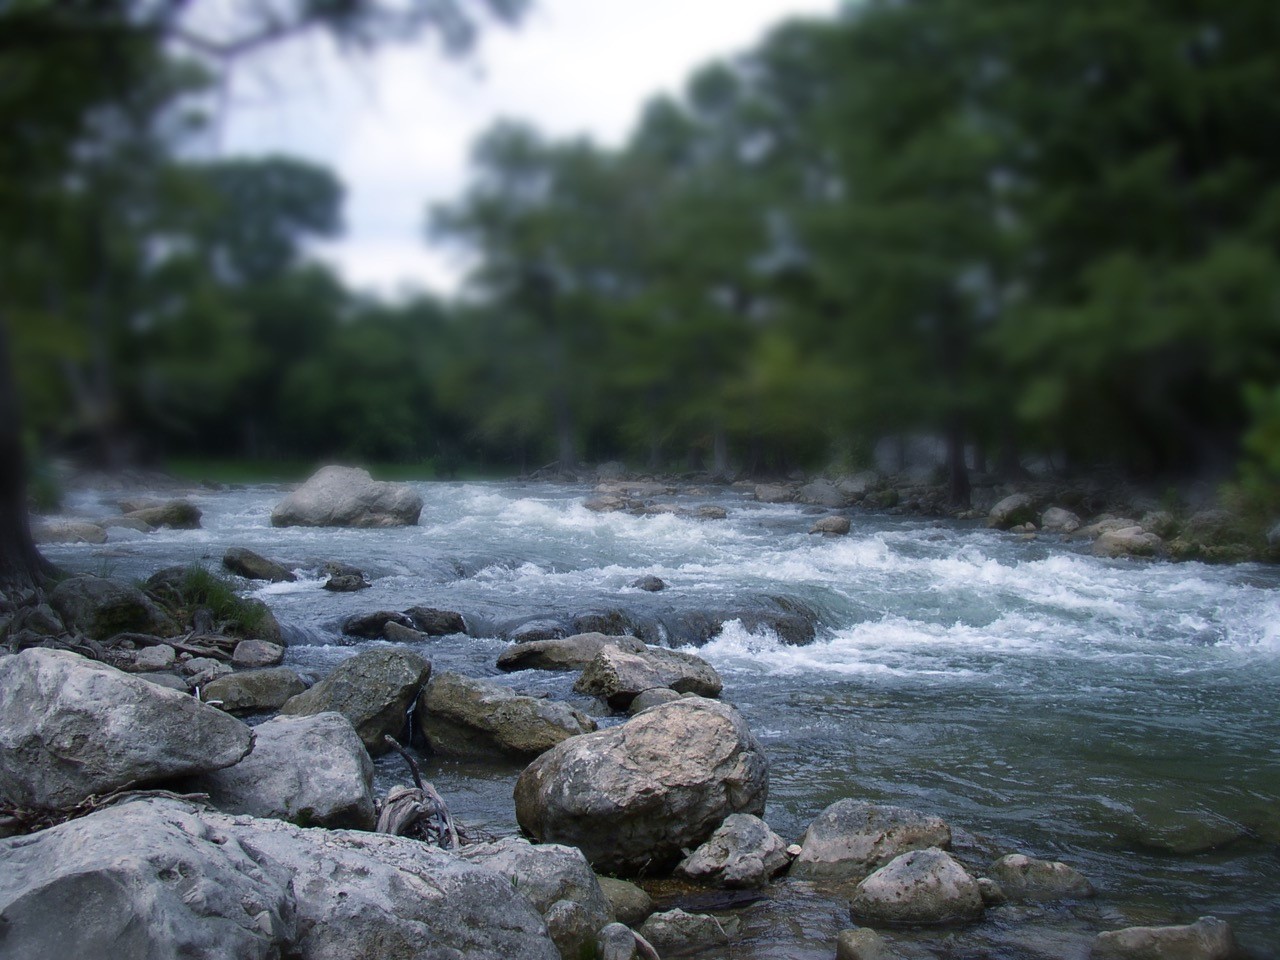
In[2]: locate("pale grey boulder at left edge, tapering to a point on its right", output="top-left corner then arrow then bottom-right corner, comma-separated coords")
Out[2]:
0,649 -> 253,809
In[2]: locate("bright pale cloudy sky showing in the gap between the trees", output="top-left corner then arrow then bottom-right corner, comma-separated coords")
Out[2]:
216,0 -> 837,296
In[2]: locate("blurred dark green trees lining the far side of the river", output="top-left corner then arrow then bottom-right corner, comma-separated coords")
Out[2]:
0,0 -> 1280,512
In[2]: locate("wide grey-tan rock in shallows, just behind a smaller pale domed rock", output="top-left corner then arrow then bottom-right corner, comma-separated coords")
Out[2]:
790,800 -> 951,881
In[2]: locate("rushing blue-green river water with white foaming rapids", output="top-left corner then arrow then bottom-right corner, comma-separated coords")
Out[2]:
47,483 -> 1280,957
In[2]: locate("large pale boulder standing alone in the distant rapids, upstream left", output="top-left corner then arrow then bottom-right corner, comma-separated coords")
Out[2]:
271,466 -> 422,527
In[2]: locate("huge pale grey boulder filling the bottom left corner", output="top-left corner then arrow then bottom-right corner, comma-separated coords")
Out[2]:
0,799 -> 559,960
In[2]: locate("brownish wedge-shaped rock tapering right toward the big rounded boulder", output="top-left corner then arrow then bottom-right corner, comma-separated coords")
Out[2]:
417,672 -> 595,758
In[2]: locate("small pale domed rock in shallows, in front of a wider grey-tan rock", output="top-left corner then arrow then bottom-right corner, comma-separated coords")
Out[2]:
850,847 -> 983,924
